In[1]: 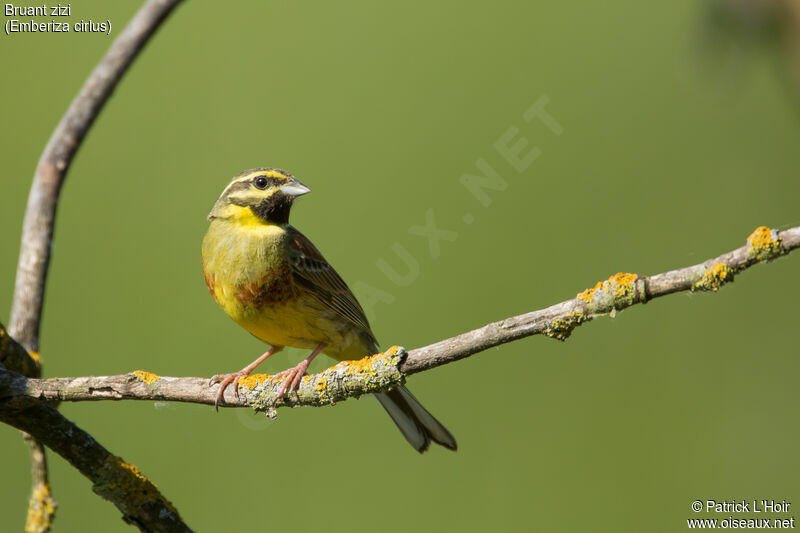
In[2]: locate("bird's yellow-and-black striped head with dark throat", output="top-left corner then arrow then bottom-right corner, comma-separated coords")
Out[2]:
208,168 -> 311,224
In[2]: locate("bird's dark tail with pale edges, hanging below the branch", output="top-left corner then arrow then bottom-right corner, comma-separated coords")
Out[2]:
375,385 -> 458,453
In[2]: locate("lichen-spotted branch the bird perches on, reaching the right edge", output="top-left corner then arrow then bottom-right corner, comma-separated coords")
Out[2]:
0,223 -> 800,416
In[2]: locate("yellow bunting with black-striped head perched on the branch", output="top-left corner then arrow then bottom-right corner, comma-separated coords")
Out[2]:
202,168 -> 457,453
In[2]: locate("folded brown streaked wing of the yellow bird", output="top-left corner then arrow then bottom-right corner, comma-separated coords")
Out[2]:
287,226 -> 378,346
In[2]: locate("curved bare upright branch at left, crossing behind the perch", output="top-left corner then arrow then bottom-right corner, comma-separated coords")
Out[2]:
9,0 -> 180,531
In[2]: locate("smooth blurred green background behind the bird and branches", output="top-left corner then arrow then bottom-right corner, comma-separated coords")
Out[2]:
0,0 -> 800,532
